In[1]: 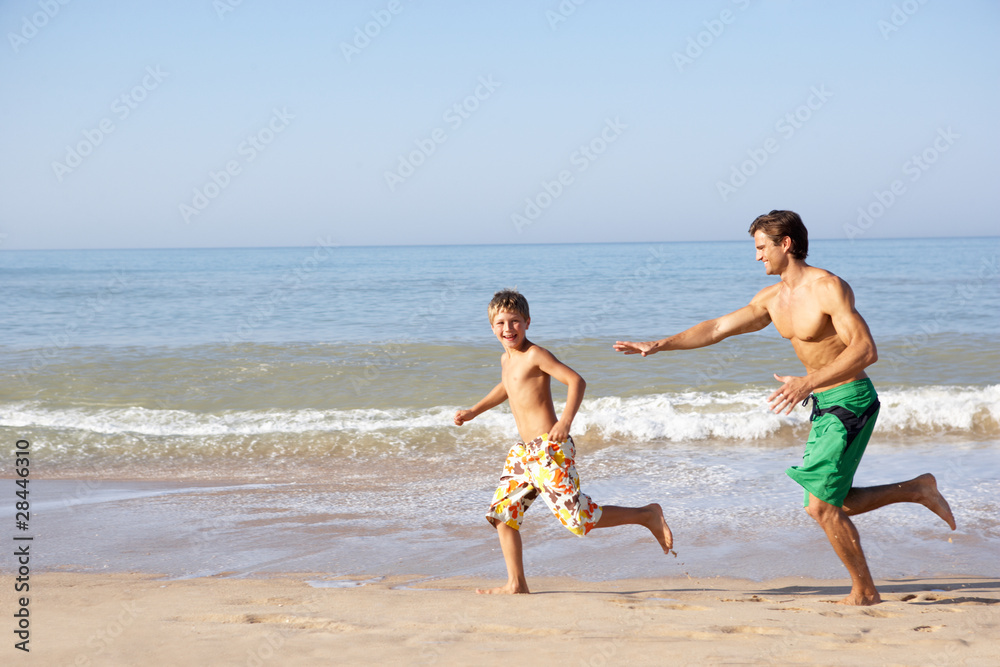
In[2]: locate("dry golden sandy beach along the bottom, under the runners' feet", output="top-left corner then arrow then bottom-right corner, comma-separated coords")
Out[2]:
2,572 -> 1000,666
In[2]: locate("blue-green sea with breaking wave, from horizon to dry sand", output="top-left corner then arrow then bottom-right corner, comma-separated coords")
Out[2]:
0,238 -> 1000,578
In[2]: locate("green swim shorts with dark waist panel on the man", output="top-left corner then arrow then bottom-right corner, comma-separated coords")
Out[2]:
785,378 -> 879,507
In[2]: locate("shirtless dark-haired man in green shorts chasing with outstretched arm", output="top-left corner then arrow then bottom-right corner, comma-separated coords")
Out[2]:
614,211 -> 955,605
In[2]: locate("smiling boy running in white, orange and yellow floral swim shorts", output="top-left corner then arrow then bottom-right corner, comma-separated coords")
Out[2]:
455,290 -> 673,593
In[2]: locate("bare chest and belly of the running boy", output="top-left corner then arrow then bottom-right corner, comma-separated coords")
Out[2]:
500,340 -> 557,442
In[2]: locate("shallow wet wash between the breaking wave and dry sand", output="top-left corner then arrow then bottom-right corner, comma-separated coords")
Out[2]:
13,475 -> 997,581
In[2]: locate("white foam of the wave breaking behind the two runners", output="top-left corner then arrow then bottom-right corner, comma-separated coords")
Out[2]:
0,385 -> 1000,441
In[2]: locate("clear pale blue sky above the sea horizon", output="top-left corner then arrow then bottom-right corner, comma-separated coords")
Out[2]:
0,0 -> 1000,249
